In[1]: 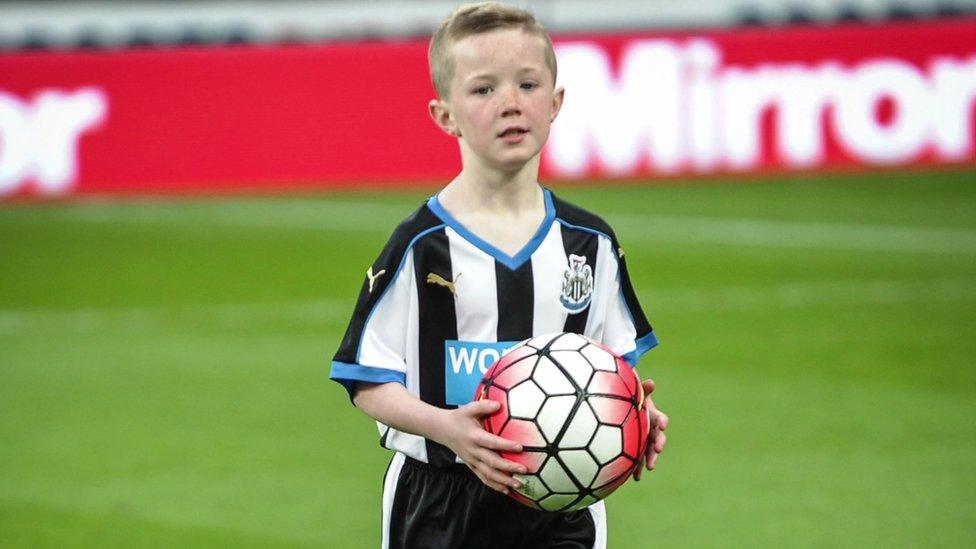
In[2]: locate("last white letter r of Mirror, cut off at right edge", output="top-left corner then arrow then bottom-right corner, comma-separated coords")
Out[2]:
931,55 -> 976,160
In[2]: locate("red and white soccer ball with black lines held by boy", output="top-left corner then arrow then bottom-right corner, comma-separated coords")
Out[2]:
475,333 -> 649,511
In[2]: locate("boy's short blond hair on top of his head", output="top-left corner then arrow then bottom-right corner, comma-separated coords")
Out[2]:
427,2 -> 556,99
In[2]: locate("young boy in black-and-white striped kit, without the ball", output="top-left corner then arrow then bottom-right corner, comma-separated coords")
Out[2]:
331,2 -> 668,548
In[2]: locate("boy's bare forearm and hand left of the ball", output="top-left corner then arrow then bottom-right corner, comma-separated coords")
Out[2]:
353,382 -> 526,494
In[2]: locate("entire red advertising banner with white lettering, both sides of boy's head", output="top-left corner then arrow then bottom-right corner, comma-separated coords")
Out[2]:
0,20 -> 976,197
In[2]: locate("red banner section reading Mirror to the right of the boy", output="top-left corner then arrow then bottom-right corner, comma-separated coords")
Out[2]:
544,20 -> 976,177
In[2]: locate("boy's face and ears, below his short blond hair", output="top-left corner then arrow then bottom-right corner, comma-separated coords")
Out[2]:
431,29 -> 563,170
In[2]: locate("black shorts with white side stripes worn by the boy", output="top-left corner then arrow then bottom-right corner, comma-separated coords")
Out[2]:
382,453 -> 606,549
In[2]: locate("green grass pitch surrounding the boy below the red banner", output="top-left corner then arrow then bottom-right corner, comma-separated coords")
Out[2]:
0,171 -> 976,548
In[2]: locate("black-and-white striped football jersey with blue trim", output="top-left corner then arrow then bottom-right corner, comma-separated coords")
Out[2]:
330,189 -> 657,465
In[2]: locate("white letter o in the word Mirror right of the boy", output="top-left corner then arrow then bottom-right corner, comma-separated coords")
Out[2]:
834,59 -> 931,164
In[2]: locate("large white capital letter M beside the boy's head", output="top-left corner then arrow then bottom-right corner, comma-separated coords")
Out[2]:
546,40 -> 685,175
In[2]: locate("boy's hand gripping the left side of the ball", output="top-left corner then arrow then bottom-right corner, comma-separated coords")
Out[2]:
438,400 -> 526,494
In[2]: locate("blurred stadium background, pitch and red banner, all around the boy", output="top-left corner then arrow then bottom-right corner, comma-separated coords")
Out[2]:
0,0 -> 976,548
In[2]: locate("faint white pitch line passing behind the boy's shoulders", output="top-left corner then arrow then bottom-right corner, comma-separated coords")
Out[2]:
17,201 -> 976,255
